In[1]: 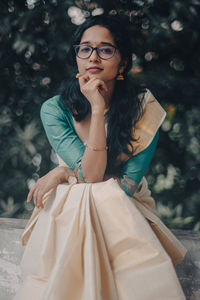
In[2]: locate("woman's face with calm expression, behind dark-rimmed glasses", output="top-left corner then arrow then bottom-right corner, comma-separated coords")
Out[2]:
76,25 -> 124,85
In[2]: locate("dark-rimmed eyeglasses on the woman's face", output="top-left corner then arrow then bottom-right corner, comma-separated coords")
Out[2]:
73,45 -> 117,59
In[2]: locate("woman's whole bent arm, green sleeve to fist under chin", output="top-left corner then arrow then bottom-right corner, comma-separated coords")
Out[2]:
41,75 -> 107,182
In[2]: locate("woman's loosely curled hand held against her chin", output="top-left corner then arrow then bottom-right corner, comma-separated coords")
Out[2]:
79,74 -> 108,111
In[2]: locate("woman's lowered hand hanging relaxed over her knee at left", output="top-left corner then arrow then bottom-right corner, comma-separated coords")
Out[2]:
27,167 -> 74,208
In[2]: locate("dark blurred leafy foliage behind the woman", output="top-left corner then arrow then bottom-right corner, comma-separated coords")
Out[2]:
0,0 -> 200,231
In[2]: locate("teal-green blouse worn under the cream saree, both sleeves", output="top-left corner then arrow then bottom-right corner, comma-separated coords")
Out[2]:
40,95 -> 158,196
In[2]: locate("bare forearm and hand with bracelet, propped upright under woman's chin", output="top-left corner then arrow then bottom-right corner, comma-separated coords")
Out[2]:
79,75 -> 108,182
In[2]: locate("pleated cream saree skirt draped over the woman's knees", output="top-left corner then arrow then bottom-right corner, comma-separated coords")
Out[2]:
14,179 -> 185,300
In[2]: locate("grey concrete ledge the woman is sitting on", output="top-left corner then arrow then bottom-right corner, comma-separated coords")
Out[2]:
0,218 -> 200,300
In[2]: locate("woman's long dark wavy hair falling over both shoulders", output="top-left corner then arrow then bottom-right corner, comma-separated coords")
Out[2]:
60,15 -> 145,173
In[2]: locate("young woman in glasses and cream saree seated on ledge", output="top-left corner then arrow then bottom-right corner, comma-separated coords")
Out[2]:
14,15 -> 186,300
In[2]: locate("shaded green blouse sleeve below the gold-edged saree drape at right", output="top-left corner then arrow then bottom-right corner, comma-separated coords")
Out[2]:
120,131 -> 158,197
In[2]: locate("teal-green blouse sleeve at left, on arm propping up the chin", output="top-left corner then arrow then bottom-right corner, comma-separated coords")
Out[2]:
40,96 -> 85,170
